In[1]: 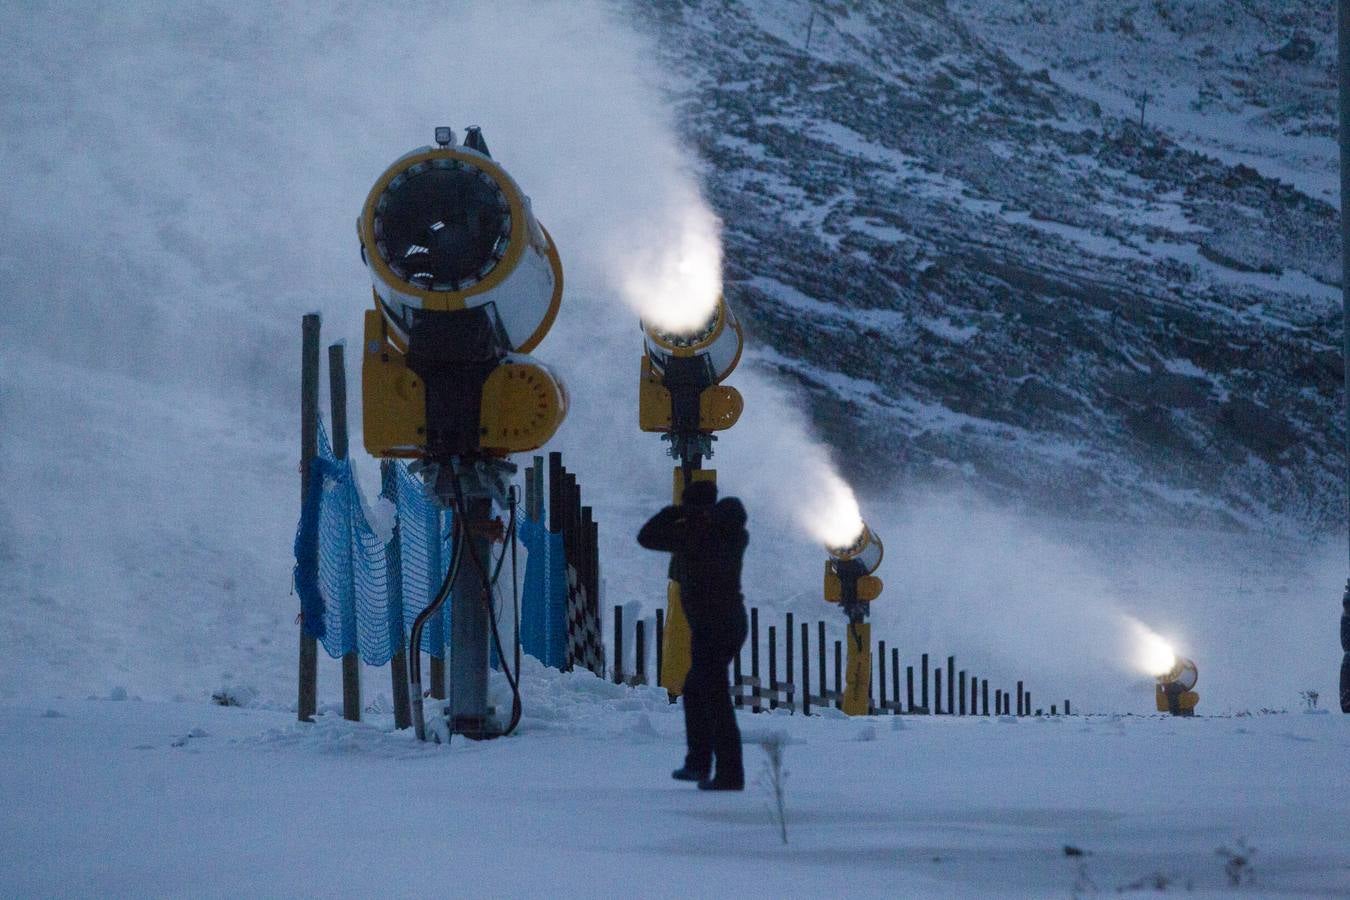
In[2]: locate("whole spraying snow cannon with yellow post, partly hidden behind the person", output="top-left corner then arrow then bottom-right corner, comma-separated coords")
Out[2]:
637,297 -> 744,700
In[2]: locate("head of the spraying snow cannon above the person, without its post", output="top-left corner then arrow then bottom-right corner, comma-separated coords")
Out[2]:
637,297 -> 744,434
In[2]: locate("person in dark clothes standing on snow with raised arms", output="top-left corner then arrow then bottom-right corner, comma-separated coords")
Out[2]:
637,482 -> 749,791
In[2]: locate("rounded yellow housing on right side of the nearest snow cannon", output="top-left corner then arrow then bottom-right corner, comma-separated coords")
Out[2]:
479,358 -> 567,455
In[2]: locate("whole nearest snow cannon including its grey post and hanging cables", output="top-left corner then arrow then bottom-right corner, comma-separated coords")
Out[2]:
356,128 -> 567,739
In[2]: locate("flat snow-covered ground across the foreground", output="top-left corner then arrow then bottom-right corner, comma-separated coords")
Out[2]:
0,665 -> 1350,897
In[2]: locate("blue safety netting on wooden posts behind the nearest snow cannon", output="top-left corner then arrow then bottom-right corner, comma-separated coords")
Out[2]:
294,422 -> 567,668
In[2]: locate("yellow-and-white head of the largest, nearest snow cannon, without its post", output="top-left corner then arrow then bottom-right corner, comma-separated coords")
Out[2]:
356,128 -> 567,460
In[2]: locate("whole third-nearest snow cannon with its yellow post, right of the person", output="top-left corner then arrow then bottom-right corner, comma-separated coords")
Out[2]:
825,525 -> 884,715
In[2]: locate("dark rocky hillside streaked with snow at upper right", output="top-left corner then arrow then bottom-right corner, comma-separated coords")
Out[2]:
632,0 -> 1345,530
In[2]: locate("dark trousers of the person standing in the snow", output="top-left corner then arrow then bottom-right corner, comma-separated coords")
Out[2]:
682,609 -> 748,781
